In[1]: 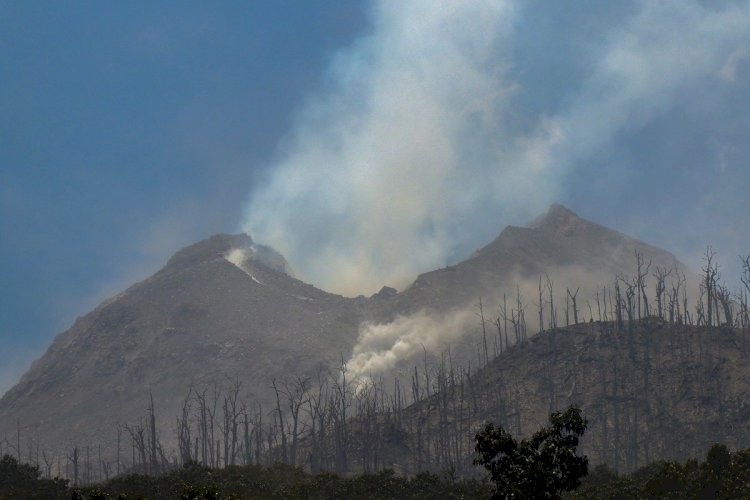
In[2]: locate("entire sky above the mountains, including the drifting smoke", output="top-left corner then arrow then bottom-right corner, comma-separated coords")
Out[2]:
0,0 -> 750,392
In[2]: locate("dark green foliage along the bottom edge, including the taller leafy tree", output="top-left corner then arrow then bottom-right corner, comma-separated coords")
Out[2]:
17,438 -> 750,500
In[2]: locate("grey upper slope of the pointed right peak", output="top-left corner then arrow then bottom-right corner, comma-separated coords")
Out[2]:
383,204 -> 691,317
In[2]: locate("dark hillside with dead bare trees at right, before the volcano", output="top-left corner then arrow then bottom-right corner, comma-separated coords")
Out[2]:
358,317 -> 750,474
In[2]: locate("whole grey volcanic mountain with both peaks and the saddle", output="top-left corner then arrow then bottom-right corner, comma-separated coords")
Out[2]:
0,205 -> 687,460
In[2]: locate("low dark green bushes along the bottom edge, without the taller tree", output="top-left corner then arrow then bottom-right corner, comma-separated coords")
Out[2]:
10,434 -> 750,500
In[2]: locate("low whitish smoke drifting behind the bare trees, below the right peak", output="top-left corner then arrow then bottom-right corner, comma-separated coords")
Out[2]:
347,256 -> 697,380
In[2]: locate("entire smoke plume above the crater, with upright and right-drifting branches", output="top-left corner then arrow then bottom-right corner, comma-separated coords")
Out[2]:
244,0 -> 750,295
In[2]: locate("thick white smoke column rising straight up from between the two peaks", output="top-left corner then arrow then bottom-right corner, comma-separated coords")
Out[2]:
245,0 -> 560,294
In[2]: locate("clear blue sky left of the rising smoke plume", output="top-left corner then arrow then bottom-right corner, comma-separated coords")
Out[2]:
0,1 -> 366,391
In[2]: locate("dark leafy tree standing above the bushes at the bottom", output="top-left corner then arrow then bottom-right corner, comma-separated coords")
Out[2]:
474,406 -> 588,498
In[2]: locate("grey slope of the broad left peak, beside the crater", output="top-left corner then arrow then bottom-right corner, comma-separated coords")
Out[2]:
0,235 -> 370,456
